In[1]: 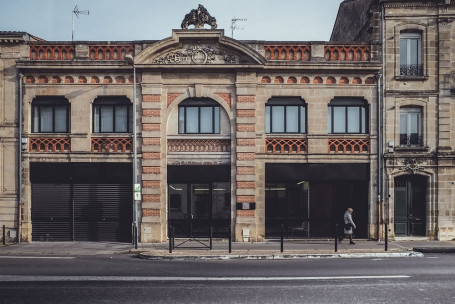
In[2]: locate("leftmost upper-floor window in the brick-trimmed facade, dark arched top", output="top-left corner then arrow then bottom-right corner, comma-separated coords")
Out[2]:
32,96 -> 70,133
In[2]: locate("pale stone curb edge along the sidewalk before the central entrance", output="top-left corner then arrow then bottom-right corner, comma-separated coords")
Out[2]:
137,251 -> 423,261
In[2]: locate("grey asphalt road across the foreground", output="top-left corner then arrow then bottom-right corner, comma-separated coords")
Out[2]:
0,254 -> 455,304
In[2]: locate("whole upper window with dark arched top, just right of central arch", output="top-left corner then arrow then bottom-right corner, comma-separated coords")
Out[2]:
265,97 -> 306,133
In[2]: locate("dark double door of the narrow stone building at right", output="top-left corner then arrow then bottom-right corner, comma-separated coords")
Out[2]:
395,175 -> 428,236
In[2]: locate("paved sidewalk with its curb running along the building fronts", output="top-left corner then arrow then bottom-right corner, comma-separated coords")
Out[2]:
0,239 -> 455,259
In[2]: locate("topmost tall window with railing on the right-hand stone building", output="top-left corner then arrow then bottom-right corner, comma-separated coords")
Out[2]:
400,32 -> 423,76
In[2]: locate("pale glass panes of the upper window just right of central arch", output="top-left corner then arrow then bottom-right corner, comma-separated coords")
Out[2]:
265,102 -> 306,133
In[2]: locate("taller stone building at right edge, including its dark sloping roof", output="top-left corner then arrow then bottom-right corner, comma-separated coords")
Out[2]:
331,0 -> 455,240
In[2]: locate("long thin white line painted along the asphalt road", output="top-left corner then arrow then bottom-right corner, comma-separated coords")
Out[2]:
0,275 -> 410,282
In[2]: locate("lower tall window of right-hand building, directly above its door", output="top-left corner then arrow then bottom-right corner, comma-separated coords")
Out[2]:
400,107 -> 423,147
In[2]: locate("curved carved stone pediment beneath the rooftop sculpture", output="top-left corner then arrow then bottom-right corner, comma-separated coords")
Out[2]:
135,29 -> 265,66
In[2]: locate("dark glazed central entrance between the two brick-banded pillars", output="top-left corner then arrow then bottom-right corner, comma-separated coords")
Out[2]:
168,165 -> 231,238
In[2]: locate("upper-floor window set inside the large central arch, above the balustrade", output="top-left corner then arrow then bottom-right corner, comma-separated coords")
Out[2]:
179,99 -> 220,134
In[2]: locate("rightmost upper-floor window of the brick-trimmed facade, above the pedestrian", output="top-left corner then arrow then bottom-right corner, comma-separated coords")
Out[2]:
327,98 -> 368,134
